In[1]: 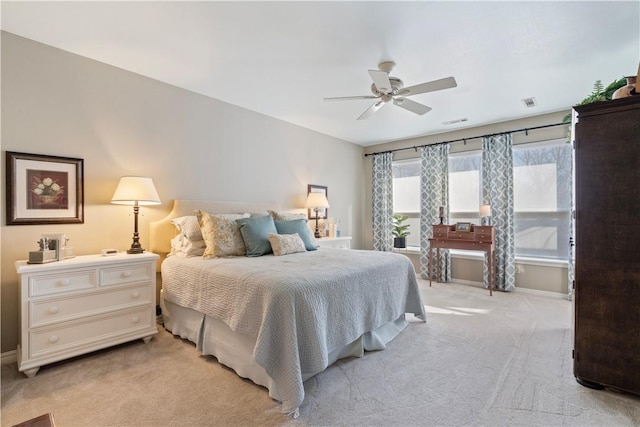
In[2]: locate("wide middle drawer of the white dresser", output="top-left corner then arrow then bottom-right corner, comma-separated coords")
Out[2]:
29,285 -> 155,328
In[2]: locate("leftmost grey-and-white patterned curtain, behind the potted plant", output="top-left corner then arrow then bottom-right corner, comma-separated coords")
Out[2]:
371,153 -> 393,251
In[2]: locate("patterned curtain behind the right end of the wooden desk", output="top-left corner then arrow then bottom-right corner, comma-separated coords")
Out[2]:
482,134 -> 515,291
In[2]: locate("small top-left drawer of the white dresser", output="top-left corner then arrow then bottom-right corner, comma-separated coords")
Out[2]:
29,269 -> 97,297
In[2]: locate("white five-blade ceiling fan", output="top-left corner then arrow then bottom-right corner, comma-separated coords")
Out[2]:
324,61 -> 458,120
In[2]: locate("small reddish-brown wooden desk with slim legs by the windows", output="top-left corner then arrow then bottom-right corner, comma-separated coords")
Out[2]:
429,224 -> 496,296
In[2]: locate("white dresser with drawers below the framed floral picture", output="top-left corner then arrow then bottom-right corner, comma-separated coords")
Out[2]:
16,253 -> 158,377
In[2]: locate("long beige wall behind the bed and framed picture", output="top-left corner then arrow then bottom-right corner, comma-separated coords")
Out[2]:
0,32 -> 365,352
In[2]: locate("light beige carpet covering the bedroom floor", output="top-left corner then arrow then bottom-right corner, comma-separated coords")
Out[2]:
1,281 -> 640,426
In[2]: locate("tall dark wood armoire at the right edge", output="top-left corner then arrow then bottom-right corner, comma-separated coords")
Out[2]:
573,95 -> 640,394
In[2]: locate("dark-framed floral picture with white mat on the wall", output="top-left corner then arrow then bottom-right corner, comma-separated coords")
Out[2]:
6,151 -> 84,225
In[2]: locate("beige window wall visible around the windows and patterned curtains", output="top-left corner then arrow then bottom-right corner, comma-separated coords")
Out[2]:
363,111 -> 569,294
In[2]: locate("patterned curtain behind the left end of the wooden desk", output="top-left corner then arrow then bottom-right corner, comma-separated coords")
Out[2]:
420,144 -> 451,282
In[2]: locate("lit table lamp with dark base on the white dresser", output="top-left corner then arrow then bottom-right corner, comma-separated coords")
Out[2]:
111,176 -> 160,254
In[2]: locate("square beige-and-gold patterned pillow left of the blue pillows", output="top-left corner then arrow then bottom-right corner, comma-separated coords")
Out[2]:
196,211 -> 249,258
